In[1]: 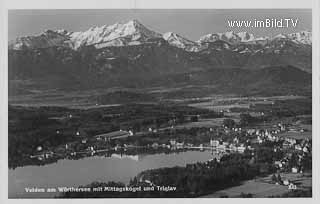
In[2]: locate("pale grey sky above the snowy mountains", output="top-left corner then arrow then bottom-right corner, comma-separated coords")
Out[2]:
8,9 -> 312,41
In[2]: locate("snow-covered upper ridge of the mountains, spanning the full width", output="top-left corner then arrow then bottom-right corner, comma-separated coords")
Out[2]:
9,20 -> 312,52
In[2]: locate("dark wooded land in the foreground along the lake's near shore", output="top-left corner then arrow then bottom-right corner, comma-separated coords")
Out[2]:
61,153 -> 274,198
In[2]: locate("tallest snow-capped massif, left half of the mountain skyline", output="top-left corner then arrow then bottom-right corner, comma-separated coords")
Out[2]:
10,20 -> 162,49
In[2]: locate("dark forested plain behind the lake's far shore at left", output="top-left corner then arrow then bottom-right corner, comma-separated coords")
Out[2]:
8,104 -> 221,168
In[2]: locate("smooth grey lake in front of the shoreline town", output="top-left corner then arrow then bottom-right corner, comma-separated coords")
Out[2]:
8,150 -> 217,198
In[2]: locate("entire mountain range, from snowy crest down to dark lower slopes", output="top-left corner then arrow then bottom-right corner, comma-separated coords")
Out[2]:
9,20 -> 312,97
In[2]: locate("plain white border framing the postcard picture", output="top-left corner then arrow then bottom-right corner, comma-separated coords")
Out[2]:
0,0 -> 320,204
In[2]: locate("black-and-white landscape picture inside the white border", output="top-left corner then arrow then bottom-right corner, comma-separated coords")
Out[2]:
2,0 -> 319,199
